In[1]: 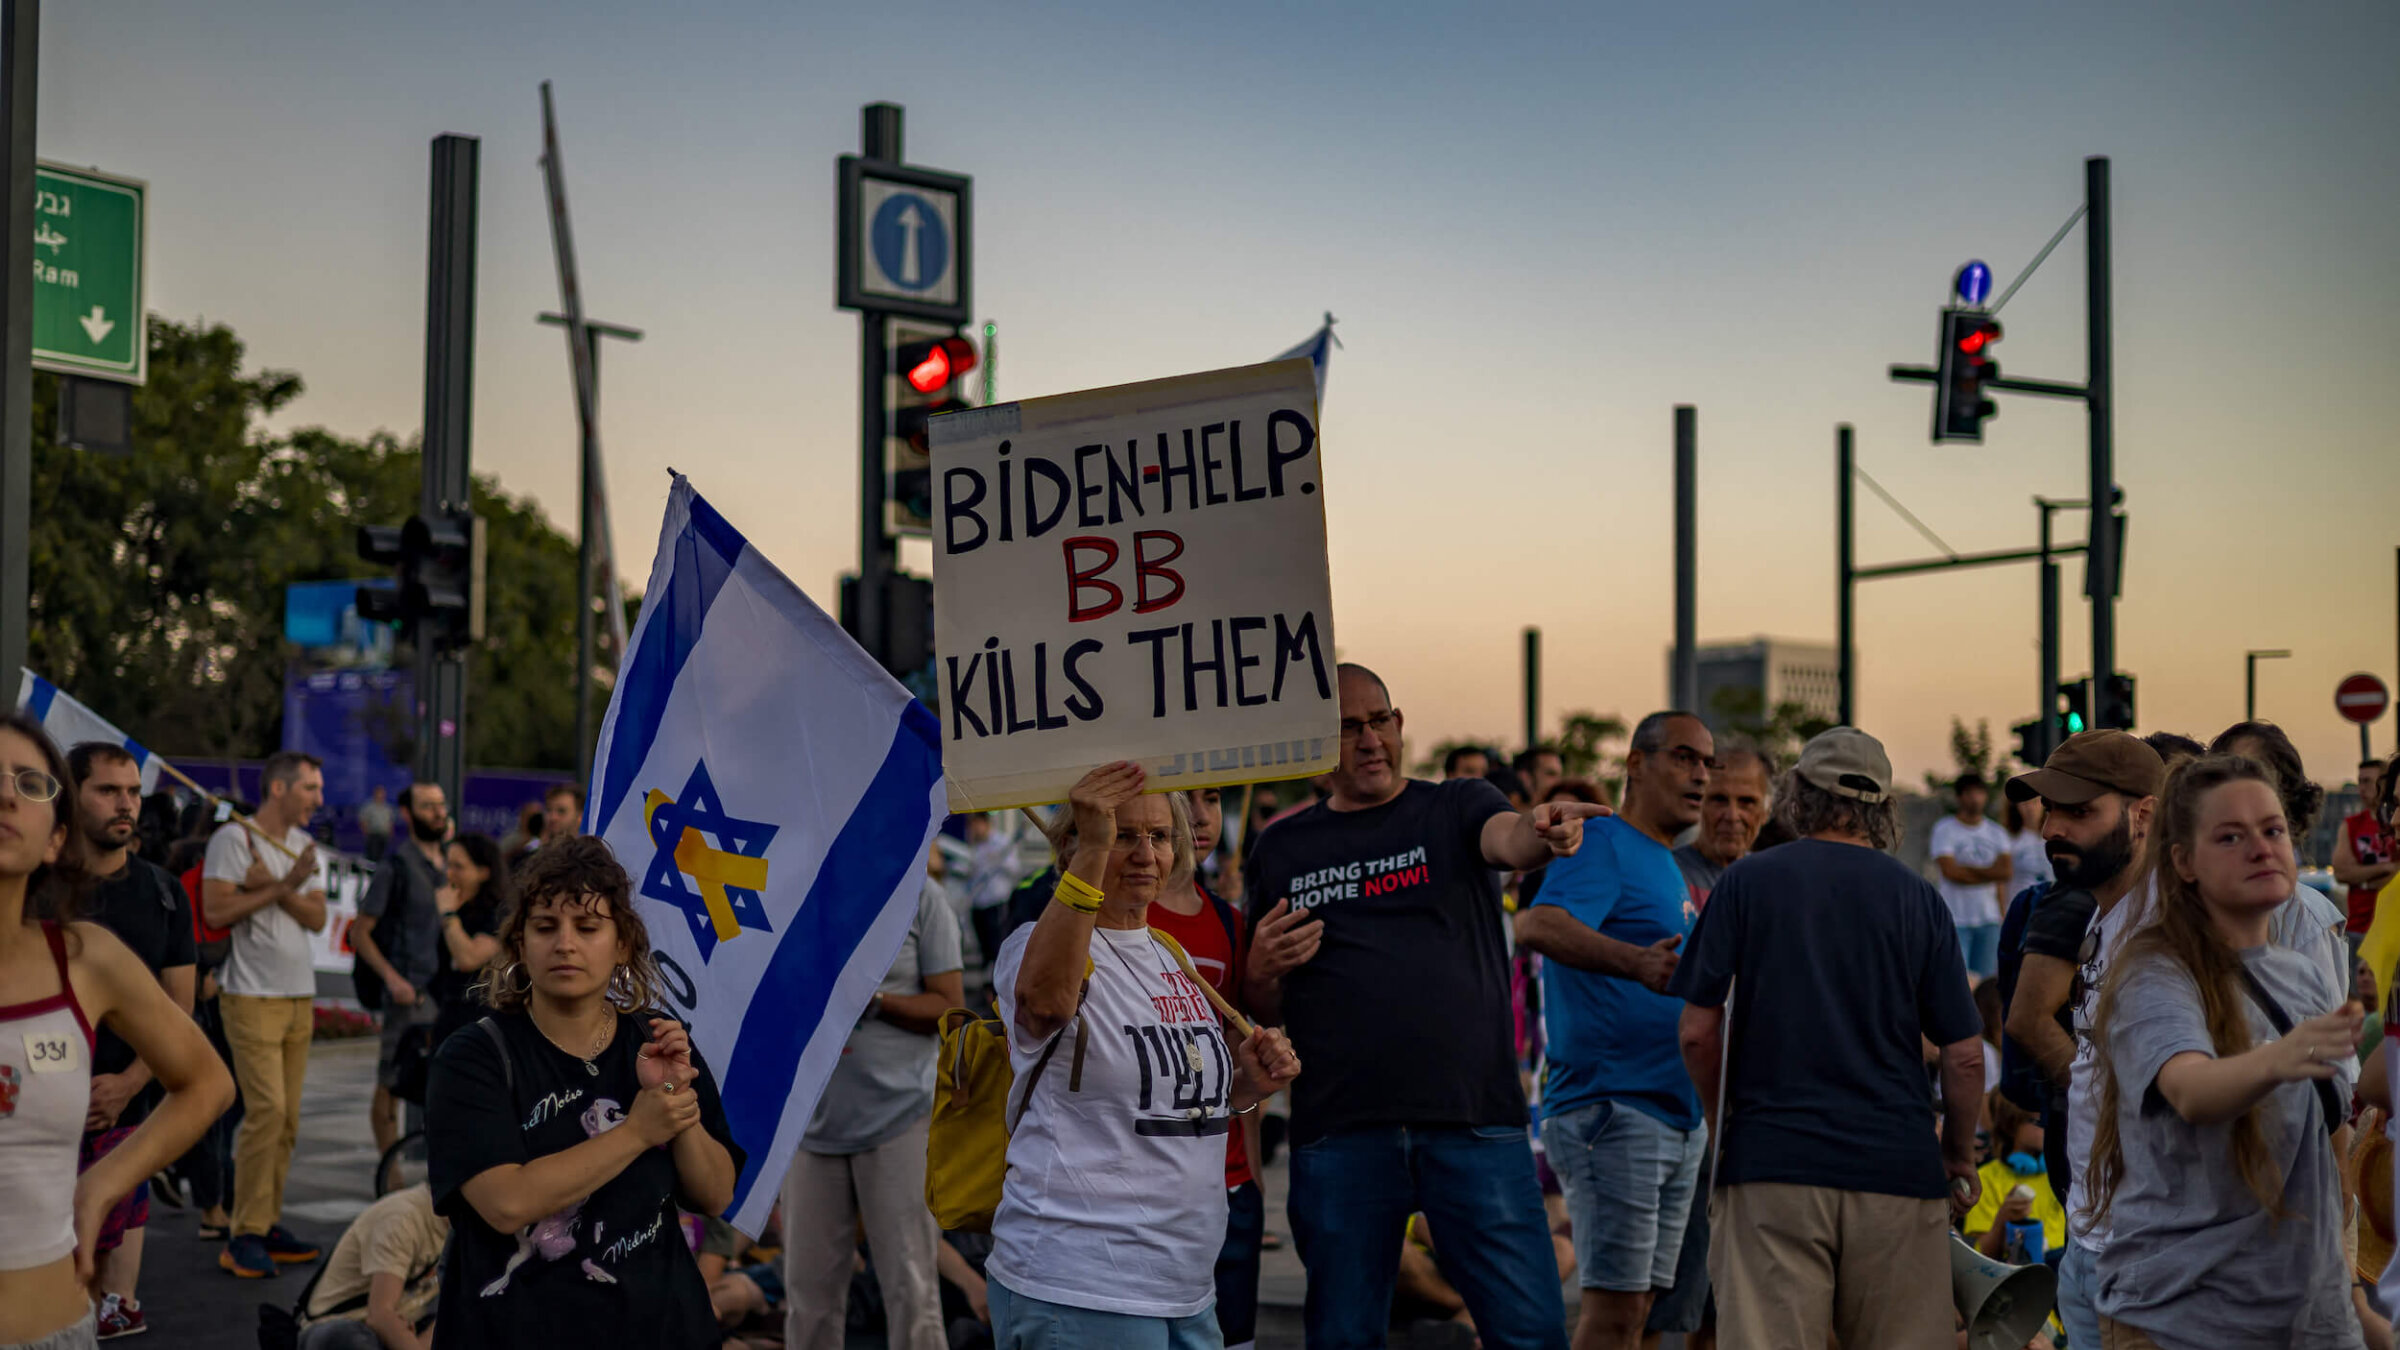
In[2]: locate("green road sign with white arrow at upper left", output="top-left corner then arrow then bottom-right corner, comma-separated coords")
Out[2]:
34,163 -> 149,384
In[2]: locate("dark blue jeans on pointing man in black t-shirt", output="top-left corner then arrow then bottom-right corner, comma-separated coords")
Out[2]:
1291,1124 -> 1567,1350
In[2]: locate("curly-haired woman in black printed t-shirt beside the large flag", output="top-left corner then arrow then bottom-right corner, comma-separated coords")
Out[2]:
425,836 -> 744,1350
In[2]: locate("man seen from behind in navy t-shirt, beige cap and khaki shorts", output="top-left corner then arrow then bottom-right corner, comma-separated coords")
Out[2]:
1668,725 -> 1982,1348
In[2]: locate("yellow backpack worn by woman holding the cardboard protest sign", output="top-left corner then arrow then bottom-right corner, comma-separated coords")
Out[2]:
924,973 -> 1090,1232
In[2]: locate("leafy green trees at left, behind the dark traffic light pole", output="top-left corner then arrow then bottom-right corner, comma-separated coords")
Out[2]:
29,317 -> 597,769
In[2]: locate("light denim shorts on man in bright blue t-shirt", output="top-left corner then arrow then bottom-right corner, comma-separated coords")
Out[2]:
1541,1103 -> 1709,1292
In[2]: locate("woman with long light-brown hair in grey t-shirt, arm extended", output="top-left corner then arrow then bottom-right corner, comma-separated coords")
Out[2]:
2086,754 -> 2362,1350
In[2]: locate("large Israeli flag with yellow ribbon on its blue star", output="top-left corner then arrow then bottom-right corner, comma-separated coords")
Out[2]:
583,473 -> 946,1235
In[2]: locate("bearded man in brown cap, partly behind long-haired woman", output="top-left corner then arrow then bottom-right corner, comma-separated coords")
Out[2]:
2006,730 -> 2165,1345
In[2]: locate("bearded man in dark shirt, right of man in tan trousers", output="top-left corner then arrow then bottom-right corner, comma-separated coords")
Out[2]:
350,783 -> 449,1153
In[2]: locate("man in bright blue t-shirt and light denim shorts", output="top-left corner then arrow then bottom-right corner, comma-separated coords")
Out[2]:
1517,711 -> 1716,1350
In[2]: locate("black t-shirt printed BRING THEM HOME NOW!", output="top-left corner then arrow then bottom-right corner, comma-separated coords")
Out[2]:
1243,778 -> 1524,1143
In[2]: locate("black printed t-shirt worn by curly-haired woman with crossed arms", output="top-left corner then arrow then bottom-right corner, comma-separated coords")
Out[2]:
425,1014 -> 742,1350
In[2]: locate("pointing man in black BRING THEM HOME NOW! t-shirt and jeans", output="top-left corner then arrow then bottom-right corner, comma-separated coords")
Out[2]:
1243,665 -> 1608,1350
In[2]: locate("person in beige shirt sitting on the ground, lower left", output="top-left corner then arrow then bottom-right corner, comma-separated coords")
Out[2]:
300,1182 -> 449,1350
